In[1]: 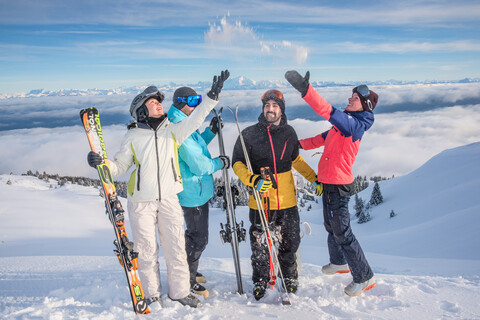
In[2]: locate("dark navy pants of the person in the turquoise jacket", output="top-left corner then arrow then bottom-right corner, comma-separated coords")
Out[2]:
182,202 -> 208,285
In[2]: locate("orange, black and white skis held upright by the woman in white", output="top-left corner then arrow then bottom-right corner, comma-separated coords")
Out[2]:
80,107 -> 150,314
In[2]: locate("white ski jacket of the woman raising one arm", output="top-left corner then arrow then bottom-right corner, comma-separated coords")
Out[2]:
108,95 -> 218,202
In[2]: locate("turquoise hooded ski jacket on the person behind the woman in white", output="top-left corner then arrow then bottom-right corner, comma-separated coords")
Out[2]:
167,105 -> 223,207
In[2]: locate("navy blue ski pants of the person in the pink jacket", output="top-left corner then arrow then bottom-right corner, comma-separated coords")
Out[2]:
323,185 -> 373,283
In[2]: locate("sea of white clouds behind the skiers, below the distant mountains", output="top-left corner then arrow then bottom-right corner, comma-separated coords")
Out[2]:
0,84 -> 480,177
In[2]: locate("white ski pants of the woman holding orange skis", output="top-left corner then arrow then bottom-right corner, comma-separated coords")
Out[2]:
128,195 -> 190,299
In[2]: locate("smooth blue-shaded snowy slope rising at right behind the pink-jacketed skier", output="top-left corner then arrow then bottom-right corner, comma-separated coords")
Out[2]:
350,143 -> 480,262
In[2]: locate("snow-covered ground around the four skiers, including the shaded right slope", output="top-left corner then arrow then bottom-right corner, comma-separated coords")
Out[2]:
0,143 -> 480,320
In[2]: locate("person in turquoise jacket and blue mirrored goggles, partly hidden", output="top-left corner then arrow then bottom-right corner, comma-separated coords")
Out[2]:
168,87 -> 230,298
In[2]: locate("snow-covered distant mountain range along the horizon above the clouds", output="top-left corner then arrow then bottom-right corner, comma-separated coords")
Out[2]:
0,76 -> 480,99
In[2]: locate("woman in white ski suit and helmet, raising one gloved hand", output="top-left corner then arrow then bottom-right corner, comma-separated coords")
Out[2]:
88,70 -> 229,311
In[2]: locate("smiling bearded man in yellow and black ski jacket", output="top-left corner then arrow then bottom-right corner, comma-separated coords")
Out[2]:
232,90 -> 321,300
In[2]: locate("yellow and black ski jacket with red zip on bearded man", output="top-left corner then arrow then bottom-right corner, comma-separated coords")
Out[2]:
232,113 -> 317,210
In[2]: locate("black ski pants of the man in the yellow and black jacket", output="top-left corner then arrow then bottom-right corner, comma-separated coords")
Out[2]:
249,206 -> 300,283
